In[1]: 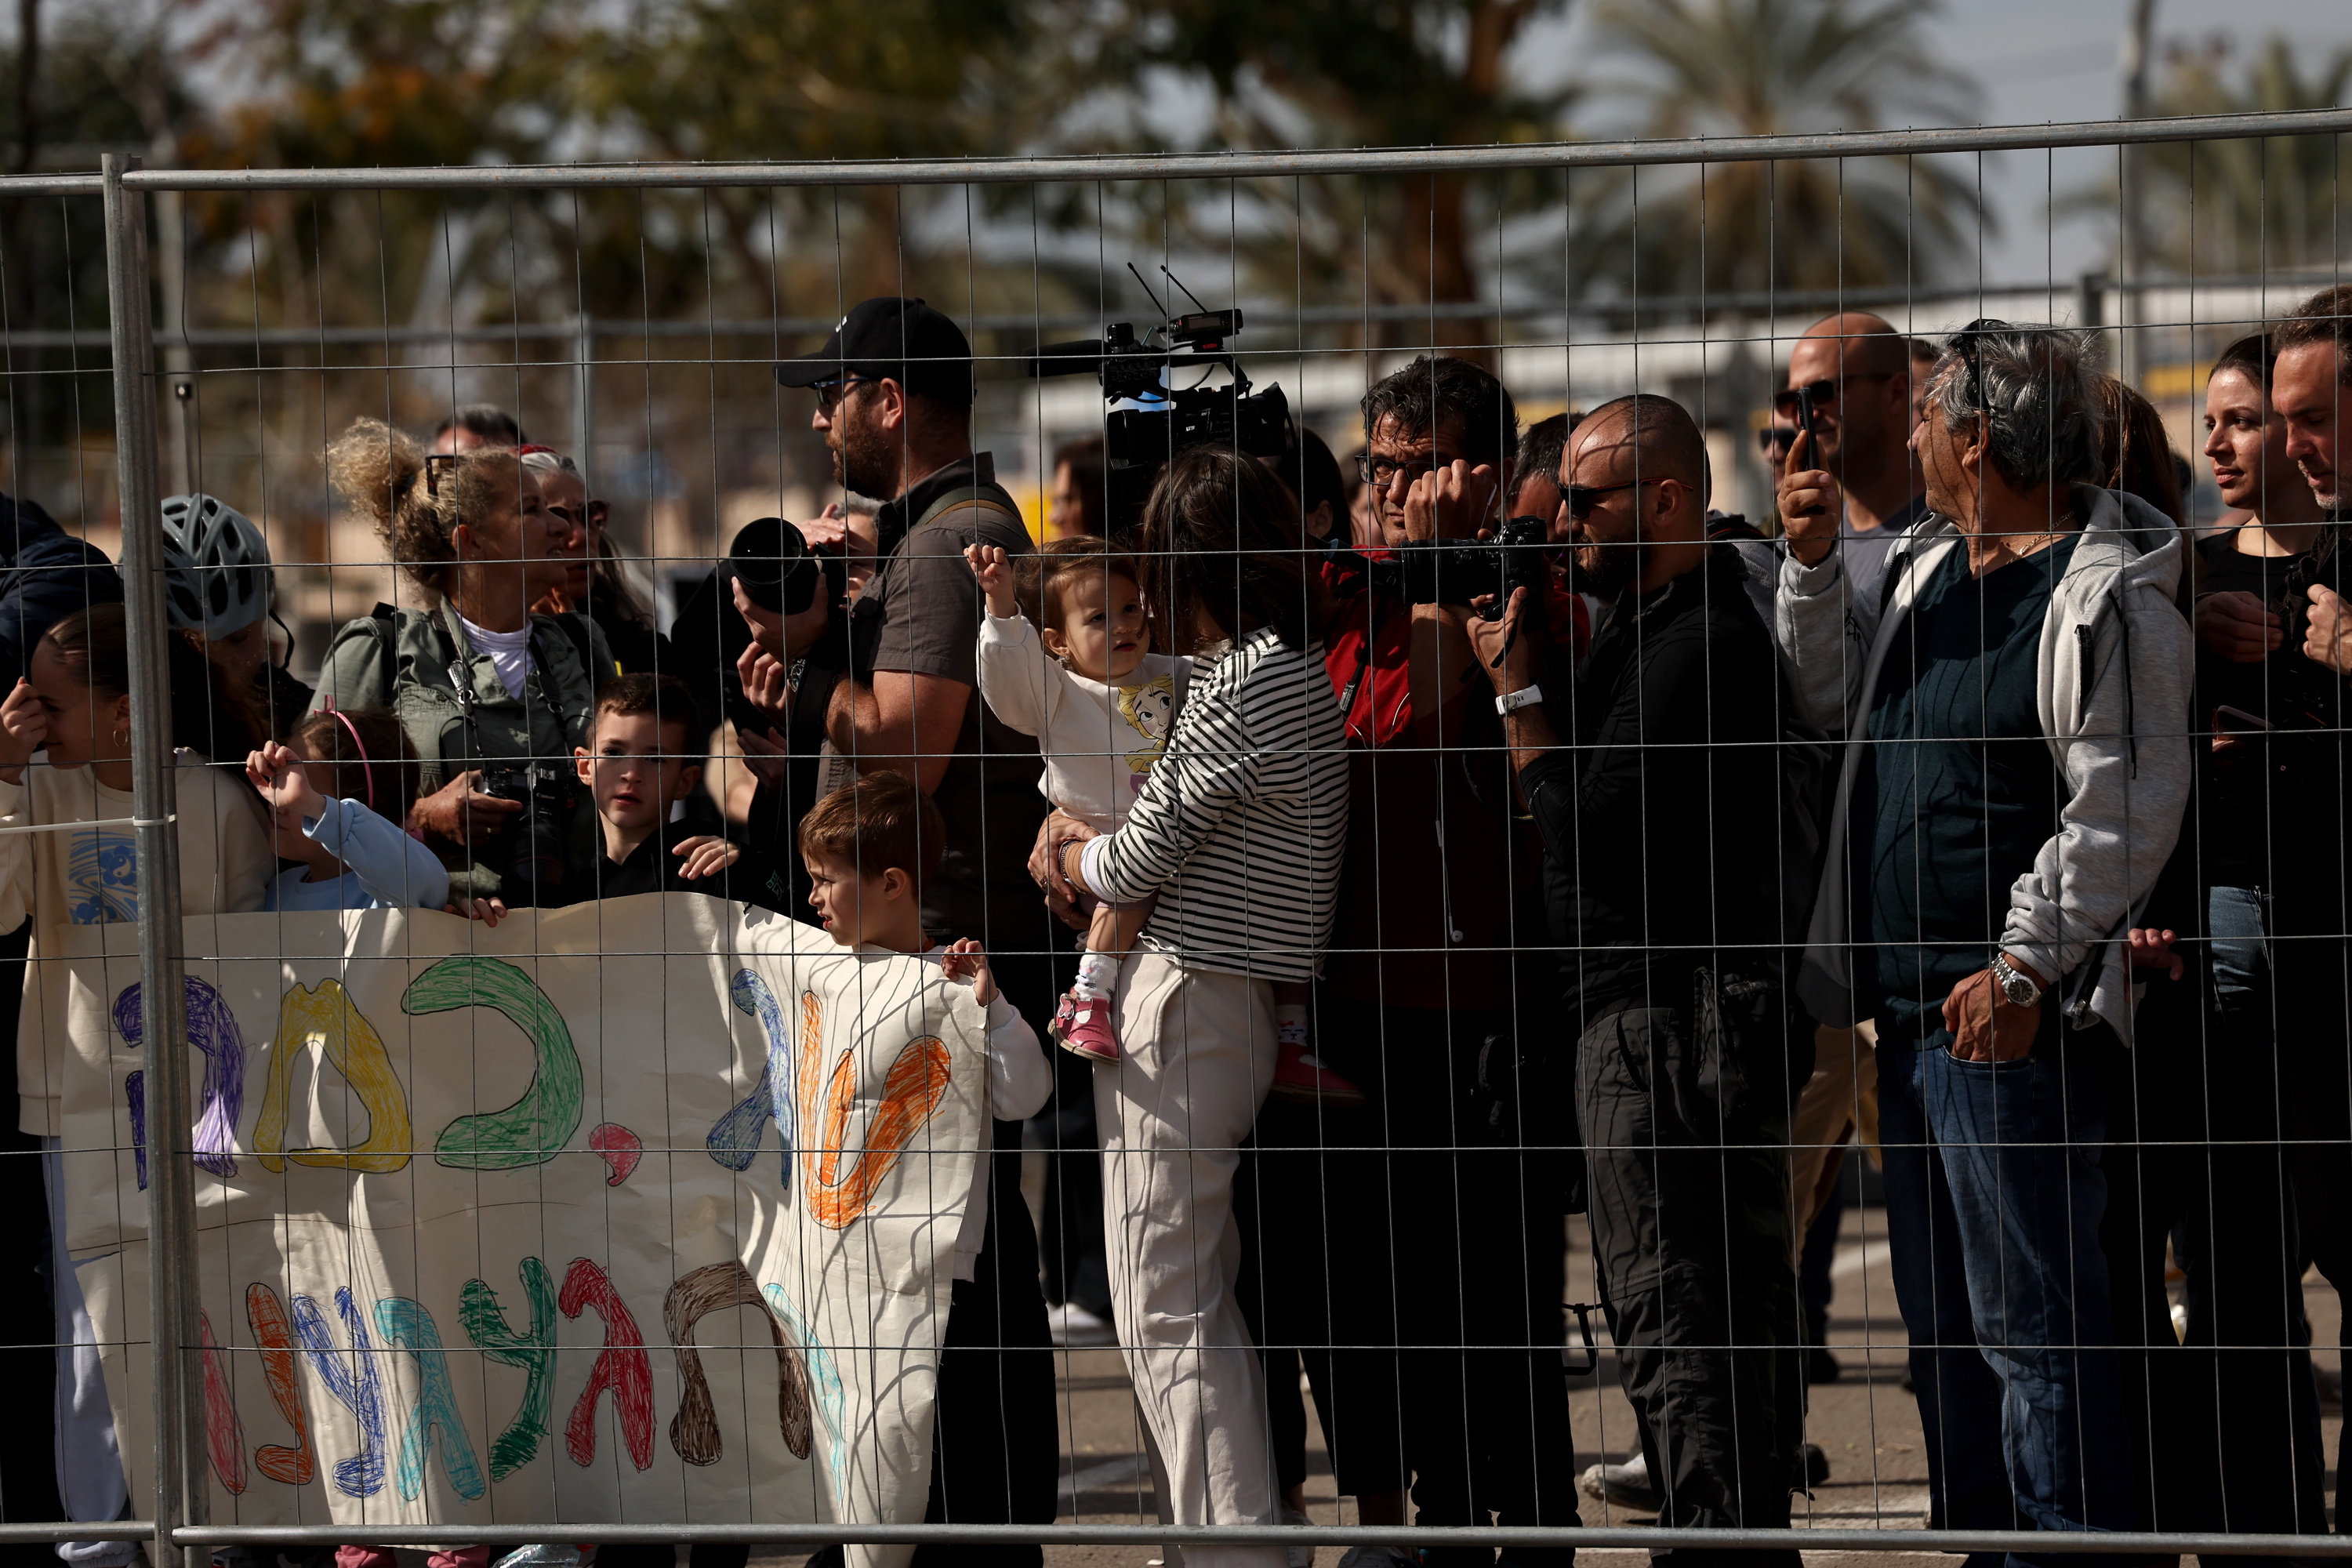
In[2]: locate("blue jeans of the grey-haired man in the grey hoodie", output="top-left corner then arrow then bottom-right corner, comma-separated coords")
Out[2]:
1879,1027 -> 2138,1561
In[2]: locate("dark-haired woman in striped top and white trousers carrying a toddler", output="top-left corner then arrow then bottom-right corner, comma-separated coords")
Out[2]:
1042,447 -> 1348,1568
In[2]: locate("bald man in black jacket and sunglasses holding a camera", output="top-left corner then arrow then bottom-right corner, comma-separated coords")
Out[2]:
1465,395 -> 1811,1568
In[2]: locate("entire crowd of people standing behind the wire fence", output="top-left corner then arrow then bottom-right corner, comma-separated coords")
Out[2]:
0,278 -> 2352,1568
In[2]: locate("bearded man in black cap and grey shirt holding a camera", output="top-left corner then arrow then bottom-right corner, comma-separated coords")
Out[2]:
731,296 -> 1058,1563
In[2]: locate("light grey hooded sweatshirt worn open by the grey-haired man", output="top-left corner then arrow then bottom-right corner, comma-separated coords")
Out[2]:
1773,485 -> 2194,1044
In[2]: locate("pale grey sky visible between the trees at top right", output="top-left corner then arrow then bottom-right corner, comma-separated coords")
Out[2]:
1519,0 -> 2352,282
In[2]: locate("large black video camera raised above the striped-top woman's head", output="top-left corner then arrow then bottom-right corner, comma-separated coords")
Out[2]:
1028,266 -> 1296,539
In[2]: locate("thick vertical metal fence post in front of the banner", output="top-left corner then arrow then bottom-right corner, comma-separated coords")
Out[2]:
101,153 -> 207,1568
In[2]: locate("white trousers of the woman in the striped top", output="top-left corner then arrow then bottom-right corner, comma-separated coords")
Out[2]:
1094,949 -> 1282,1568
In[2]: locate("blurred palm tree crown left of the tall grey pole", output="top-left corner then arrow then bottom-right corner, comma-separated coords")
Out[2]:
1571,0 -> 1990,294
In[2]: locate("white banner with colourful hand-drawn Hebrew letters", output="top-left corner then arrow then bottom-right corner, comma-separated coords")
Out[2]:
53,893 -> 988,1559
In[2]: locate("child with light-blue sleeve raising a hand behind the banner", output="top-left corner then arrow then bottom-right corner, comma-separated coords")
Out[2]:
245,706 -> 449,909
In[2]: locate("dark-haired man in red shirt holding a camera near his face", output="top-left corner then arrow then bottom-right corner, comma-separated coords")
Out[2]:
1270,355 -> 1576,1561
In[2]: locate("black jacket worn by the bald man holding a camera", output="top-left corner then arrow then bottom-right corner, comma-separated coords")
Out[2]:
1519,546 -> 1783,1020
